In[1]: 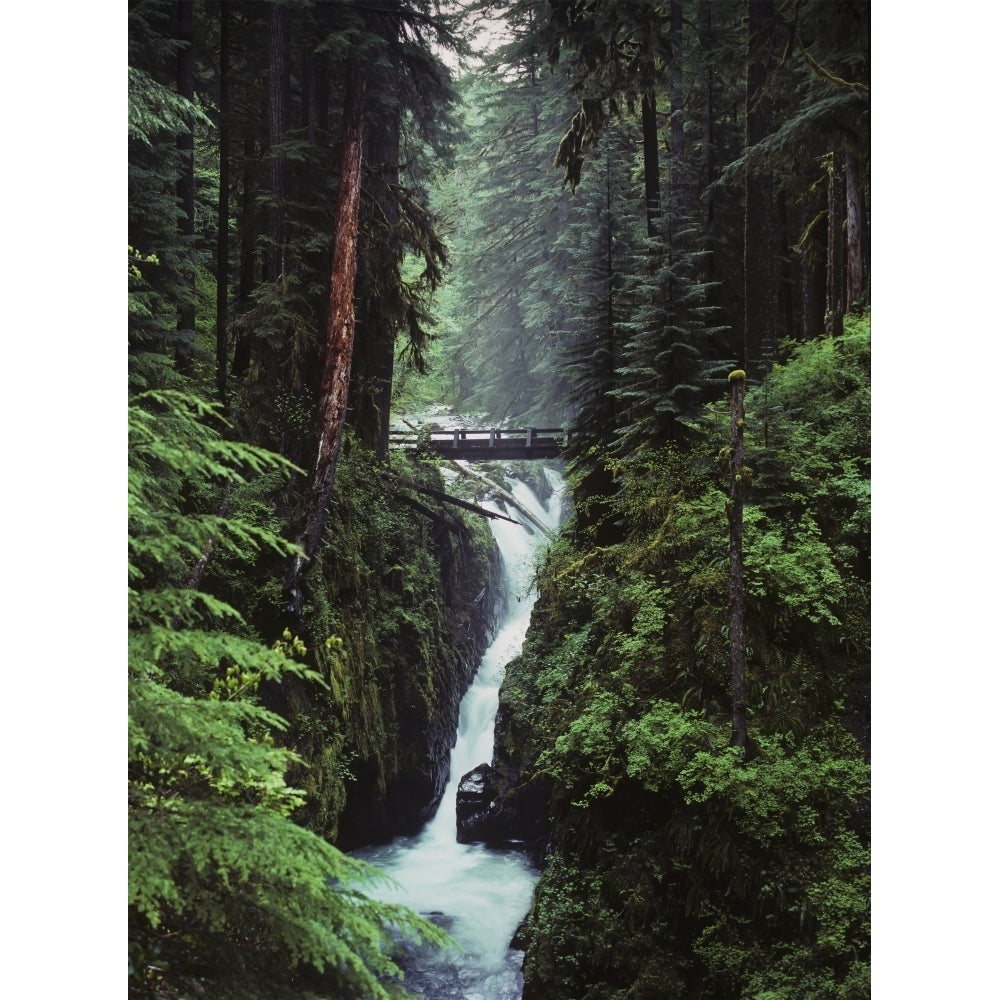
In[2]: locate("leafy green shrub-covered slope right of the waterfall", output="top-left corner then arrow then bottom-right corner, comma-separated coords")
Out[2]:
498,319 -> 870,1000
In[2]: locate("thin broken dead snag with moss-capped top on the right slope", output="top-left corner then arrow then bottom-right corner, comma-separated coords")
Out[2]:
728,369 -> 747,747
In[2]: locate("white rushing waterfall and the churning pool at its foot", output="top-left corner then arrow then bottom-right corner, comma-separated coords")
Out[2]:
355,469 -> 565,1000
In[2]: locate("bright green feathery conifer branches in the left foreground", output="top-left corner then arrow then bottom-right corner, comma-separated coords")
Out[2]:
128,391 -> 445,998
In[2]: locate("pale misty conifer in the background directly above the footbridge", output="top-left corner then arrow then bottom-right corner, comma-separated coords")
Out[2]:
440,50 -> 569,426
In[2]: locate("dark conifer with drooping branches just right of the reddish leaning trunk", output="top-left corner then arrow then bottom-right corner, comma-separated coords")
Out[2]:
351,2 -> 461,458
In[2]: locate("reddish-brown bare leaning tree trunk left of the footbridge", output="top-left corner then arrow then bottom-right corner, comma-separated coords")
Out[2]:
286,53 -> 368,611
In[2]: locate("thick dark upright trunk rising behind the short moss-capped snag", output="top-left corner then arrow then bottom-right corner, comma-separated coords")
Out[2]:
743,0 -> 775,371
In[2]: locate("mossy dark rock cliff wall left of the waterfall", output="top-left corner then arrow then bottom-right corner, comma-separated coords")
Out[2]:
258,447 -> 500,850
